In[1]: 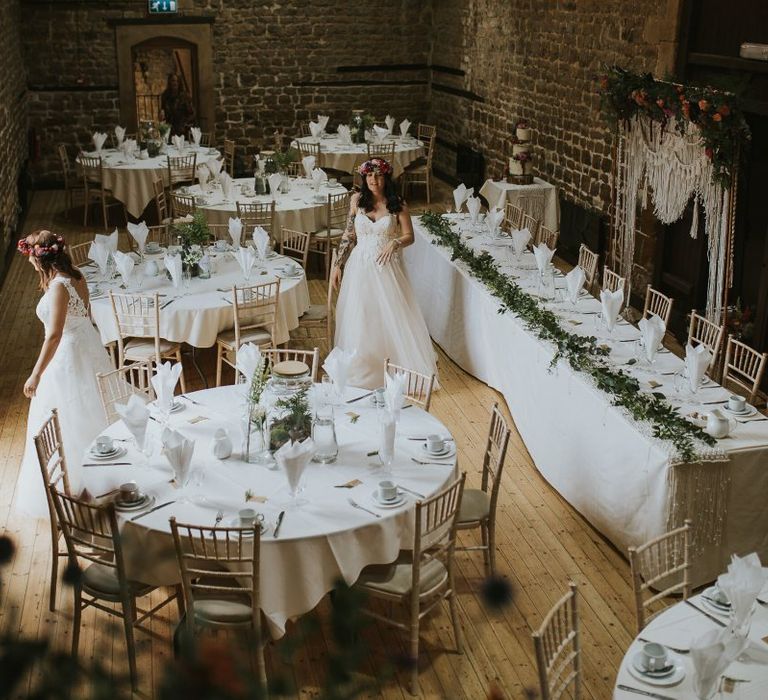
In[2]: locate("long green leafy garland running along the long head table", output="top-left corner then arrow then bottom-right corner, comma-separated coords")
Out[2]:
421,212 -> 716,462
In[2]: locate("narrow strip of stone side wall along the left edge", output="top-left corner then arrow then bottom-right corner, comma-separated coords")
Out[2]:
0,0 -> 27,277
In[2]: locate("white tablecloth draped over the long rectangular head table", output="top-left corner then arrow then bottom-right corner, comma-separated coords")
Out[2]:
404,217 -> 768,583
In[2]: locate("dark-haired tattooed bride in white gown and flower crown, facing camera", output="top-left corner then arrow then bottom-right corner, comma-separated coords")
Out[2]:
331,158 -> 436,389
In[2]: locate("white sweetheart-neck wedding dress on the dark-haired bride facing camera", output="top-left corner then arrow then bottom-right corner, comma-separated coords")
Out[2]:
335,210 -> 437,389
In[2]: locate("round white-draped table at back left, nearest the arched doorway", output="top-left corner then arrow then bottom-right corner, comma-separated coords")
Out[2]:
78,146 -> 221,219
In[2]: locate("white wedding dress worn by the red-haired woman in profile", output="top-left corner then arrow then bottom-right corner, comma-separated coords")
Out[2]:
15,276 -> 113,518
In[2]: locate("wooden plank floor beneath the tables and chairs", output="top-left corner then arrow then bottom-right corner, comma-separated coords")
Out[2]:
0,186 -> 634,700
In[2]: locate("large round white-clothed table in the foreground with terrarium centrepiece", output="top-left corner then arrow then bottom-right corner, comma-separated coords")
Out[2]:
83,385 -> 456,637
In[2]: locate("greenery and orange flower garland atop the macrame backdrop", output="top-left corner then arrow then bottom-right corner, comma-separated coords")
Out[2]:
598,66 -> 750,189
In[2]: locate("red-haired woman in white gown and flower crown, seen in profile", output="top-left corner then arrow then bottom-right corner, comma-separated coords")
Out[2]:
15,230 -> 113,518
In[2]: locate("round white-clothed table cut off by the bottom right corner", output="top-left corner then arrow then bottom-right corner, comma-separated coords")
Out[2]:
613,586 -> 768,700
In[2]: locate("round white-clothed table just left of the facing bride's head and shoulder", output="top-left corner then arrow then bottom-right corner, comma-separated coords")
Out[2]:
187,177 -> 347,235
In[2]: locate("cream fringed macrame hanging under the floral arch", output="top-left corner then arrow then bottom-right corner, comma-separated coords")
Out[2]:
611,116 -> 730,323
